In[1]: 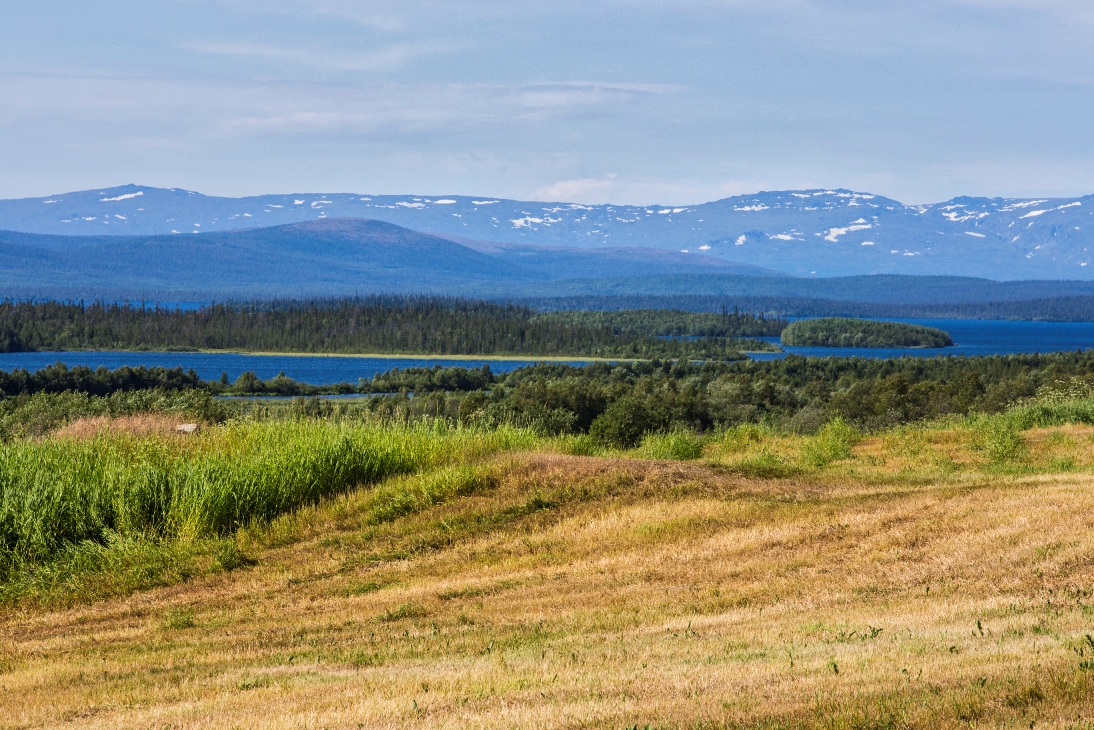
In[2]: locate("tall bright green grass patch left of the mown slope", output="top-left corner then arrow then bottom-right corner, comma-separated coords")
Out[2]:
0,420 -> 535,572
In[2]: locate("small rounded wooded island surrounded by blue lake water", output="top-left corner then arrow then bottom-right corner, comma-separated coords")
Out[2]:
780,317 -> 954,347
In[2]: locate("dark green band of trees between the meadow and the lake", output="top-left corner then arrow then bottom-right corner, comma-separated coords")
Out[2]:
8,350 -> 1094,445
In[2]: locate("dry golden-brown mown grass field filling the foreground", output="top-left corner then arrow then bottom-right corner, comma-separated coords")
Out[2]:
0,409 -> 1094,728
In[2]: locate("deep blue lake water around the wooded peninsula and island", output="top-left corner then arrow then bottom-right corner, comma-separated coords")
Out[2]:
0,320 -> 1094,385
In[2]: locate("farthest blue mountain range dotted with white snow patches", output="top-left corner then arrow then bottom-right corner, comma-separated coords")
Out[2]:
0,185 -> 1094,280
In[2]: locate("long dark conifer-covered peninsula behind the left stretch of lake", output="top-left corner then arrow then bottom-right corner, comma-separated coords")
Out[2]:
0,297 -> 785,359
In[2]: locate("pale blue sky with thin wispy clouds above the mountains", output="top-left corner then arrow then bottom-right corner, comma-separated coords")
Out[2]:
0,0 -> 1094,205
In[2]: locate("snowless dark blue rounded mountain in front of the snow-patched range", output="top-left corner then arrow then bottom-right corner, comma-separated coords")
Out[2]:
0,219 -> 765,301
